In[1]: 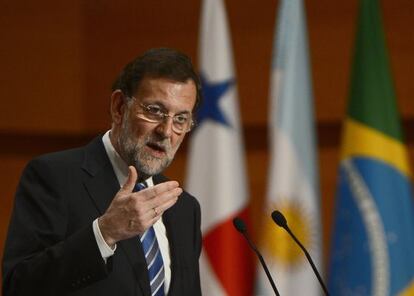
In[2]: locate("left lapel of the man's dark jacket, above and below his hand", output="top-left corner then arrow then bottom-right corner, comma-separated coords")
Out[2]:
82,137 -> 151,295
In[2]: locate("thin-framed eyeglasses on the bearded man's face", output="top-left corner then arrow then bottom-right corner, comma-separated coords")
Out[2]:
131,97 -> 194,134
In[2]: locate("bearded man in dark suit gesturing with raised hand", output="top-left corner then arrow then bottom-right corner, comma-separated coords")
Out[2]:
3,49 -> 201,296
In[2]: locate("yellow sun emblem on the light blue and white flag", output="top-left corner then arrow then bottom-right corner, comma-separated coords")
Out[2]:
262,199 -> 316,268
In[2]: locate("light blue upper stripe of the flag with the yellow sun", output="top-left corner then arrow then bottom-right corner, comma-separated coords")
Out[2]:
270,0 -> 319,192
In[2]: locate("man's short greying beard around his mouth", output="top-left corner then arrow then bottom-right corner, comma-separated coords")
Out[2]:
118,117 -> 181,179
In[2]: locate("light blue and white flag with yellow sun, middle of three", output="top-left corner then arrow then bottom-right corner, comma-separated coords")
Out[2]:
256,0 -> 322,295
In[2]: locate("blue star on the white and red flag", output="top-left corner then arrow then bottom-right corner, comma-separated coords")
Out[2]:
197,74 -> 234,126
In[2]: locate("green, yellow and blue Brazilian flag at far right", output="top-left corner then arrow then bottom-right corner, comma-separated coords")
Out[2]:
328,0 -> 414,295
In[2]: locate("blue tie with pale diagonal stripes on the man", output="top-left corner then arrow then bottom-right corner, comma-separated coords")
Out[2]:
134,183 -> 165,296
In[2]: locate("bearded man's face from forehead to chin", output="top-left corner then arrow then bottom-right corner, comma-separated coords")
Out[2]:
116,78 -> 196,177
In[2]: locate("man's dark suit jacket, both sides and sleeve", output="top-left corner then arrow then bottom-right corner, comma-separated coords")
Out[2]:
3,137 -> 201,296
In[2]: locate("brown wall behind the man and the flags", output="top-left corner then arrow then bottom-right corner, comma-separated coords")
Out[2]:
0,0 -> 414,286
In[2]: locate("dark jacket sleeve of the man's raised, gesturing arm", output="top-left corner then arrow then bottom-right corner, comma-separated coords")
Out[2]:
2,159 -> 111,296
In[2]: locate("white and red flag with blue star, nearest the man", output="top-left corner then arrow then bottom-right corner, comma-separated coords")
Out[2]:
186,0 -> 254,296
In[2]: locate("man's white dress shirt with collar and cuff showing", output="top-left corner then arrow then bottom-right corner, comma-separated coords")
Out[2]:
92,131 -> 171,295
